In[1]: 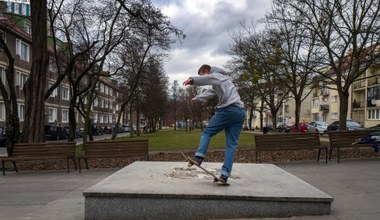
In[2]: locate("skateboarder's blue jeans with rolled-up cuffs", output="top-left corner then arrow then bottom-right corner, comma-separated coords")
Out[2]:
195,106 -> 245,177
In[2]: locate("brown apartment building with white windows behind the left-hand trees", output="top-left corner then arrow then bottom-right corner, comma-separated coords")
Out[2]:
0,1 -> 122,129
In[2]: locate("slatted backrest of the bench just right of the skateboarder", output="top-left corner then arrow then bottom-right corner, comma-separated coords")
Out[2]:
255,133 -> 320,150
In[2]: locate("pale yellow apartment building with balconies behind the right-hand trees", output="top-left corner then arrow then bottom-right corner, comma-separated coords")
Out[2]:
246,63 -> 380,128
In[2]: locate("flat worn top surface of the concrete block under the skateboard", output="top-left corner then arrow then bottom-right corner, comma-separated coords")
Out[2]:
83,161 -> 333,202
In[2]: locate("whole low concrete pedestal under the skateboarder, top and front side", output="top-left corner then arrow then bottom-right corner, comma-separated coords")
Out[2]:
83,162 -> 333,220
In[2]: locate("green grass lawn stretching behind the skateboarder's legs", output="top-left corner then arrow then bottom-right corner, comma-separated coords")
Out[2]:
119,129 -> 254,151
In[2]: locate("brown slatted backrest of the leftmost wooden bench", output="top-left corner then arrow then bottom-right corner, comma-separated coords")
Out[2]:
12,142 -> 76,157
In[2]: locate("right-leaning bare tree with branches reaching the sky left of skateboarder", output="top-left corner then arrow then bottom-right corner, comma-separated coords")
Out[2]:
112,0 -> 184,138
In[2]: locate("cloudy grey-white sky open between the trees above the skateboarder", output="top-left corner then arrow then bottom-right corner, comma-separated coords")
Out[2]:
152,0 -> 271,87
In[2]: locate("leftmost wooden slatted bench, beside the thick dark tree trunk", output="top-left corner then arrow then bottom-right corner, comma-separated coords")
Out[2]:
0,142 -> 77,175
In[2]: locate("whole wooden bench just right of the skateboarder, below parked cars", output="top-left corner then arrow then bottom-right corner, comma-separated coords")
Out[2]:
255,132 -> 328,163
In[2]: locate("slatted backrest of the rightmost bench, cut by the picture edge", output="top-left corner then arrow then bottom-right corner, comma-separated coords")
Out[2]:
328,130 -> 374,147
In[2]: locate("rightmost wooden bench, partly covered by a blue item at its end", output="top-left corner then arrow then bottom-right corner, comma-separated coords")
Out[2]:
328,130 -> 376,163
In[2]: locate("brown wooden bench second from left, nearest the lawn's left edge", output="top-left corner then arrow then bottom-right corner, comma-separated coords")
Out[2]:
78,139 -> 149,172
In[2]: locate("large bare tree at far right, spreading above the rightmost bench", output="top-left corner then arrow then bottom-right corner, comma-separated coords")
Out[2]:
275,0 -> 380,130
